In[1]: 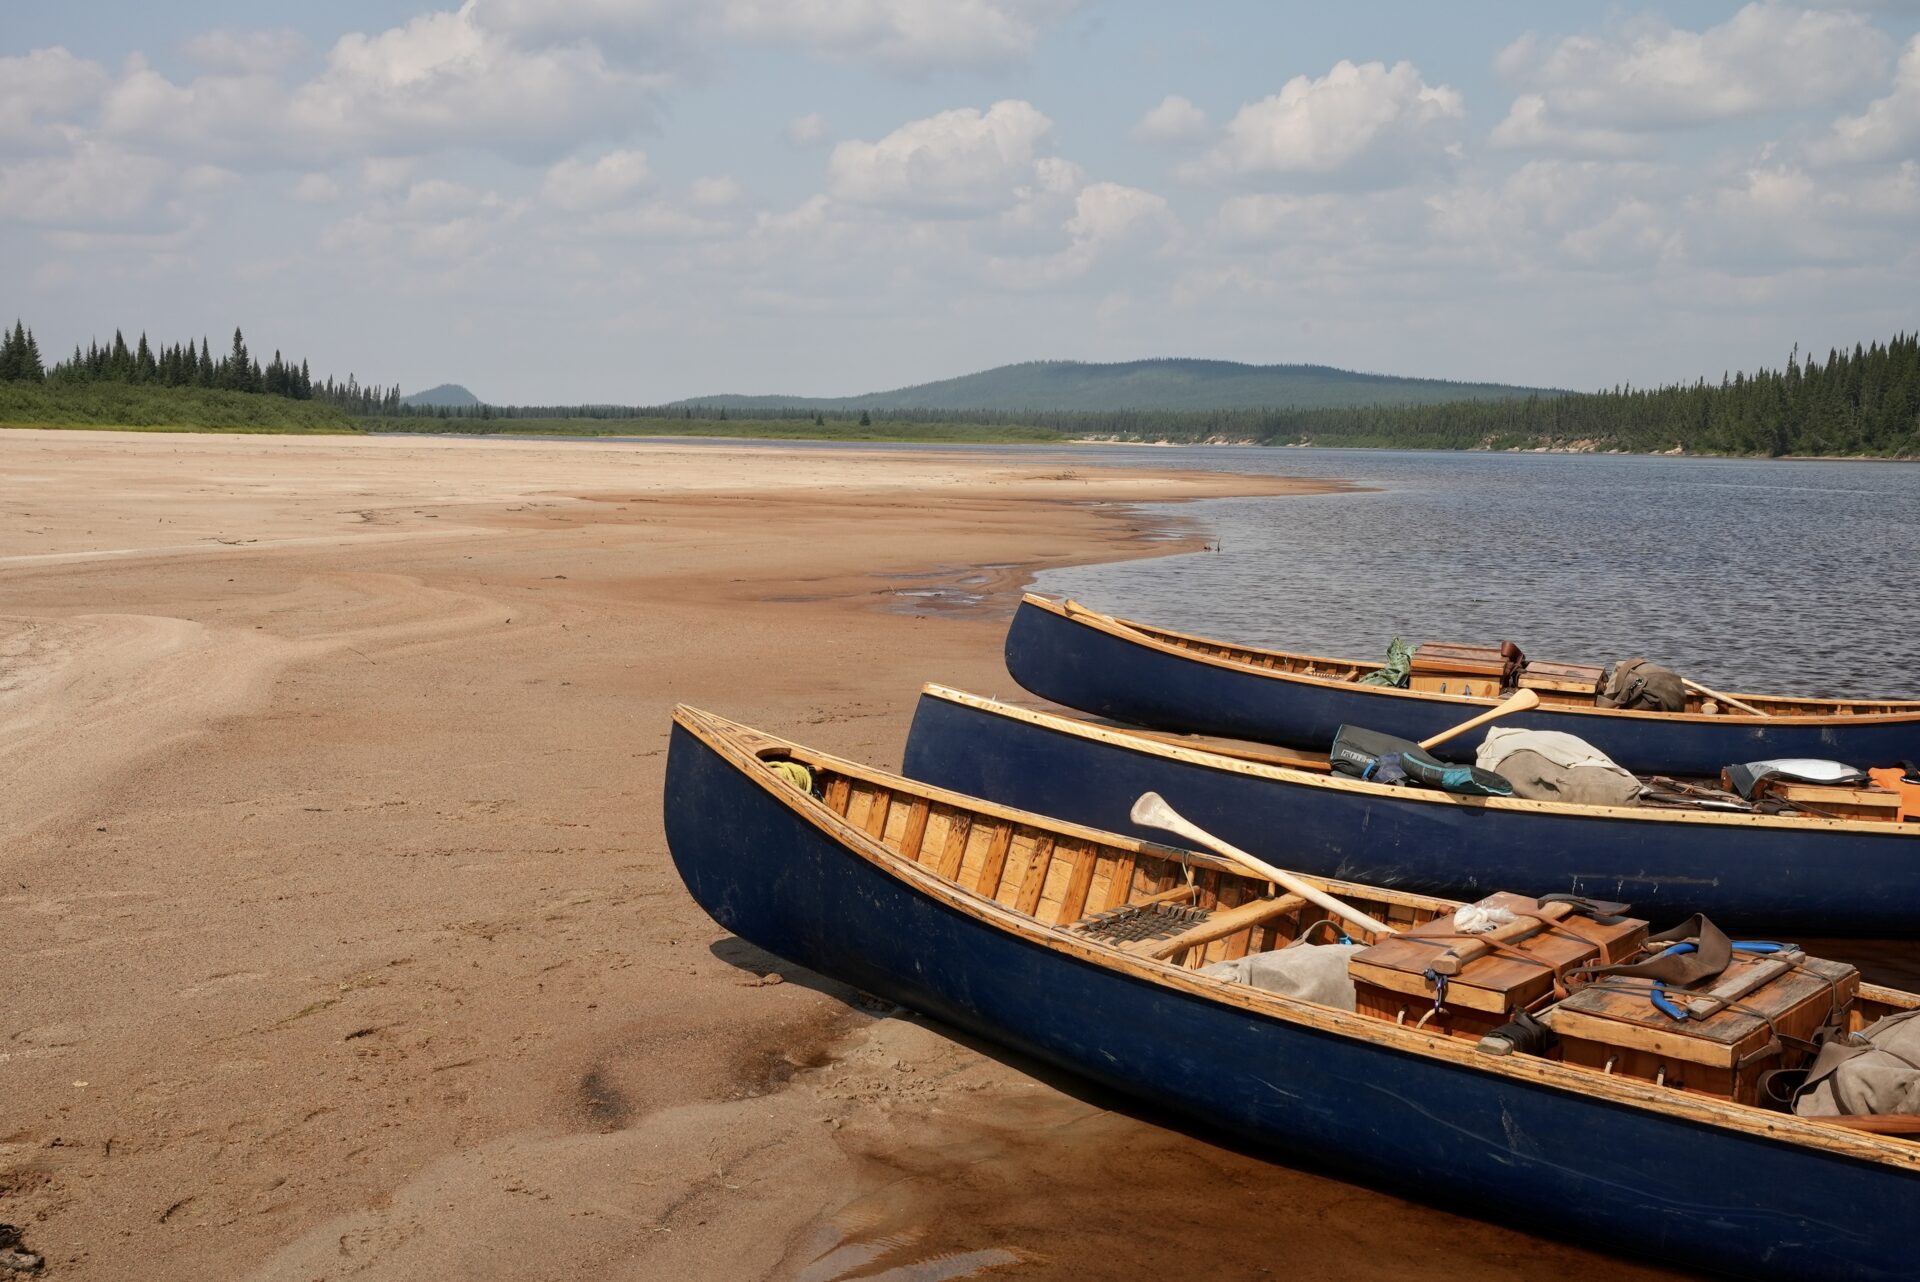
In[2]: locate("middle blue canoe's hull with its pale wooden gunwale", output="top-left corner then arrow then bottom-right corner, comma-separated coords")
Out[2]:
902,685 -> 1920,938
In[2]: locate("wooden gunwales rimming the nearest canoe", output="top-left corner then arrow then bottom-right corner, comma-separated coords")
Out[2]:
674,706 -> 1920,1173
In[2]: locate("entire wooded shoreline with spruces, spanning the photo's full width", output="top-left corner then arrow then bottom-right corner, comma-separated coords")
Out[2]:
0,322 -> 1920,459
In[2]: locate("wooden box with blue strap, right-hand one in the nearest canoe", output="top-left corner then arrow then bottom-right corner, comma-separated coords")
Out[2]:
1546,952 -> 1860,1104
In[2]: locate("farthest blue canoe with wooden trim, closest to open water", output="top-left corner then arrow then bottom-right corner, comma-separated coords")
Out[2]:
1006,595 -> 1920,777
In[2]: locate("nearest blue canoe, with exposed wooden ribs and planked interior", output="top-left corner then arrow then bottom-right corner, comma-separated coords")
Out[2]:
666,708 -> 1920,1282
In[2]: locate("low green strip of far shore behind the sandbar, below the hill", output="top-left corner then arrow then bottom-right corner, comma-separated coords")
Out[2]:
357,415 -> 1069,445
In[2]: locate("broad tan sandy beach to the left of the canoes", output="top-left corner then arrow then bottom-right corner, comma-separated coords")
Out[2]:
0,432 -> 1670,1282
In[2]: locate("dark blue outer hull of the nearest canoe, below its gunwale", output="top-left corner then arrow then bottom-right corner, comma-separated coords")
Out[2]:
666,725 -> 1920,1280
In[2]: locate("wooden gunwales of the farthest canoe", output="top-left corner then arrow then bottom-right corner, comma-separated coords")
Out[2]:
1044,593 -> 1920,729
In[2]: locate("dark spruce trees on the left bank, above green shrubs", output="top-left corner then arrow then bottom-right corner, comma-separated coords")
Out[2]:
0,321 -> 401,415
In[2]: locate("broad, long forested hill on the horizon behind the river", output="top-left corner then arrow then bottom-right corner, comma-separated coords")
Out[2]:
674,359 -> 1548,411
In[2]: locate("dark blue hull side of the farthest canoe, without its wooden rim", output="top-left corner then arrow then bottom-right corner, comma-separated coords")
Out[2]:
1006,601 -> 1920,777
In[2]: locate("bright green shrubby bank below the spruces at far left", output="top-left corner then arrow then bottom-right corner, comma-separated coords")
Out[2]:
0,380 -> 357,432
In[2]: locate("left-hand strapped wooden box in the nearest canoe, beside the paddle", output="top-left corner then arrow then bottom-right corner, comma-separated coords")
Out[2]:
1348,890 -> 1647,1038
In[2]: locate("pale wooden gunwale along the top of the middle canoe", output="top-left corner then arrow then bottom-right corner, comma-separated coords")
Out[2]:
920,681 -> 1920,839
